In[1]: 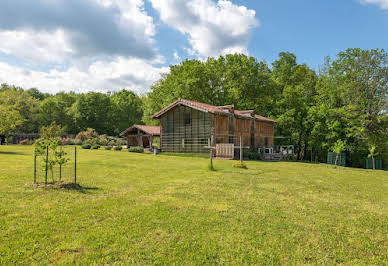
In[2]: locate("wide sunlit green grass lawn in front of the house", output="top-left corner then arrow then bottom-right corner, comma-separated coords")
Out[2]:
0,146 -> 388,265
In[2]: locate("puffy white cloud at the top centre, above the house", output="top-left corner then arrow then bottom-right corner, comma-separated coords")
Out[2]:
150,0 -> 259,56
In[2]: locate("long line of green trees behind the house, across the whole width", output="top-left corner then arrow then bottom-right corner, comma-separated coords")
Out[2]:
0,49 -> 388,166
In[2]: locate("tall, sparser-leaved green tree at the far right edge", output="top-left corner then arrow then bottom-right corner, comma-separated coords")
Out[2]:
329,49 -> 388,149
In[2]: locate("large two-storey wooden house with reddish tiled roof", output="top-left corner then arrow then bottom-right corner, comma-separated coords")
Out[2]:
152,99 -> 276,153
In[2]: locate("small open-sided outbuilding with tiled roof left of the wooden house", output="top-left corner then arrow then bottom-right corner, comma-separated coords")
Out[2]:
120,125 -> 160,148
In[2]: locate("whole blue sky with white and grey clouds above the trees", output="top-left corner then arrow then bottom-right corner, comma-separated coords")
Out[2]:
0,0 -> 388,94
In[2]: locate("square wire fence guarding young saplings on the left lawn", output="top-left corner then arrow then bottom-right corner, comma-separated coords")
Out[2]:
34,145 -> 77,184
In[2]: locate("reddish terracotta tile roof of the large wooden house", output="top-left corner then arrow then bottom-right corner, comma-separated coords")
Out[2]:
152,99 -> 276,123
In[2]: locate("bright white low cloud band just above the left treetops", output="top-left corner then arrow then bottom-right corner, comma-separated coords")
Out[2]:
0,57 -> 169,93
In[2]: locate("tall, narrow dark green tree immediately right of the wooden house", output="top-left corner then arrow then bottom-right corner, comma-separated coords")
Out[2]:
272,53 -> 317,160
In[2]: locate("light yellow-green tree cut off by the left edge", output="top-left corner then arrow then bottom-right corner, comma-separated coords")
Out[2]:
0,105 -> 23,141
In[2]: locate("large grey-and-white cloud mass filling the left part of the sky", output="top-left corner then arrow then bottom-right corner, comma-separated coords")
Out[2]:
0,0 -> 168,93
